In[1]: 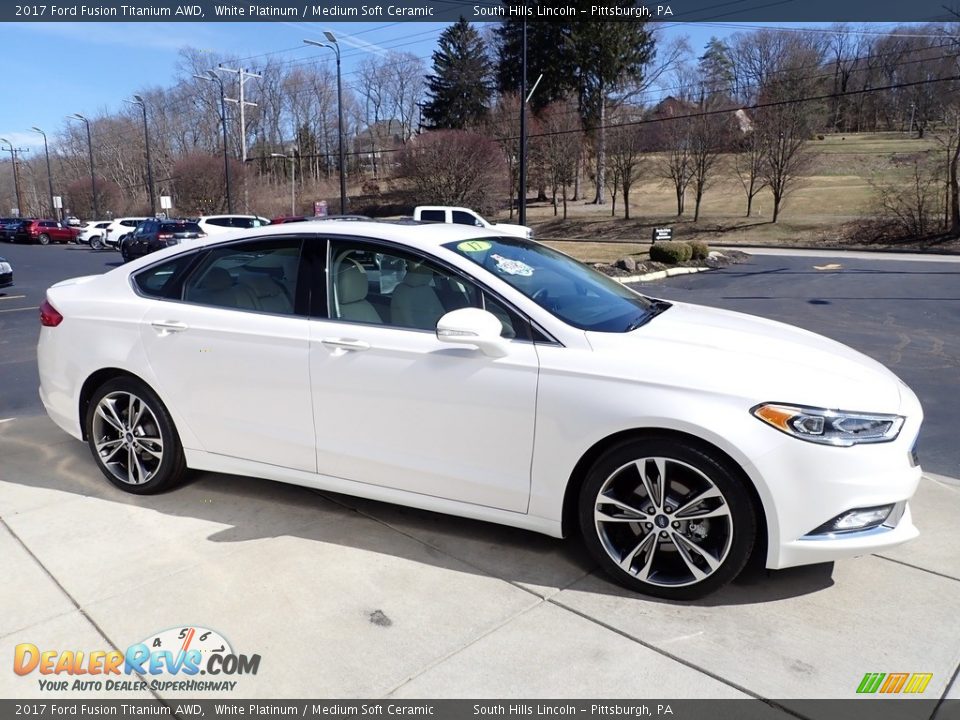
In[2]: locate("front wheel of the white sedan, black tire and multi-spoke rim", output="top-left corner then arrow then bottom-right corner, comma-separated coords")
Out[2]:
578,437 -> 757,600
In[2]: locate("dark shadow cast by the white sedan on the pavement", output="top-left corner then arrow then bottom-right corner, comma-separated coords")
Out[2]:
0,416 -> 833,607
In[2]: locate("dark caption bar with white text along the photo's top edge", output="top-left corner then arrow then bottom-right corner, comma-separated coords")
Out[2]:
0,0 -> 958,23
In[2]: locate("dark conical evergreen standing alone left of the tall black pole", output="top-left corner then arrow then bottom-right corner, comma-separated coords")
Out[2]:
423,16 -> 493,129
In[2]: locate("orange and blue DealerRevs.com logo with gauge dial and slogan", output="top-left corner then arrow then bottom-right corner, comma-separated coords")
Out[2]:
13,627 -> 260,692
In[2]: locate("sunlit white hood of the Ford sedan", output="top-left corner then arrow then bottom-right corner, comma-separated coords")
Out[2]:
587,302 -> 902,413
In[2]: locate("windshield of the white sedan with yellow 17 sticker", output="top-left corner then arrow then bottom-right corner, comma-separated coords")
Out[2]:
444,237 -> 657,332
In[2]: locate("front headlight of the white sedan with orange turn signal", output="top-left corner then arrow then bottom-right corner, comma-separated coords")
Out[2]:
750,403 -> 905,447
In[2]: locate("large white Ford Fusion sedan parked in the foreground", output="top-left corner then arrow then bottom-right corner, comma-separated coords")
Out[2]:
38,222 -> 922,599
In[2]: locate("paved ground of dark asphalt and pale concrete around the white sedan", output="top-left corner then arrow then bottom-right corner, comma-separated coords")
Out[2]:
0,240 -> 960,708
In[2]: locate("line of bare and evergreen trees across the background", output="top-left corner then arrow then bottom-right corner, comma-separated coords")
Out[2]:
0,19 -> 960,232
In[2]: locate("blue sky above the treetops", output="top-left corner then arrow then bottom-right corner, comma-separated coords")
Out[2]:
0,22 -> 856,149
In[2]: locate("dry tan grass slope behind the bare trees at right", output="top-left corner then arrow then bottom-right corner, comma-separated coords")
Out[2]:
500,133 -> 960,262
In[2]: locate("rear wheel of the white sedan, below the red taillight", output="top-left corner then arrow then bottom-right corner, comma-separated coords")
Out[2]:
84,377 -> 187,495
